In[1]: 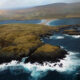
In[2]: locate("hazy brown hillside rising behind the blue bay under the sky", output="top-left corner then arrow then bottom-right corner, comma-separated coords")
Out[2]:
0,3 -> 80,19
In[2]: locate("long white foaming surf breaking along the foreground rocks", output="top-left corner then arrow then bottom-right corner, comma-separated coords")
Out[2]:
0,51 -> 80,80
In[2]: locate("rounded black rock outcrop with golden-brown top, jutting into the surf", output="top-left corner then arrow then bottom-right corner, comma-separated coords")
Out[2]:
27,44 -> 67,63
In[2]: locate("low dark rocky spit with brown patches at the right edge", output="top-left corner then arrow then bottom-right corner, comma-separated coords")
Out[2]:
53,24 -> 80,35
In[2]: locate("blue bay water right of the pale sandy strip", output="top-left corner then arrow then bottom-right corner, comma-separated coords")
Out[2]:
48,18 -> 80,26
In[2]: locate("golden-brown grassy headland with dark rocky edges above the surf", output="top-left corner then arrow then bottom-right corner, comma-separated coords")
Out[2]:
0,24 -> 66,63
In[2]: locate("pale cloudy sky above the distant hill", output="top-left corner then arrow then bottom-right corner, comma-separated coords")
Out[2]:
0,0 -> 80,9
